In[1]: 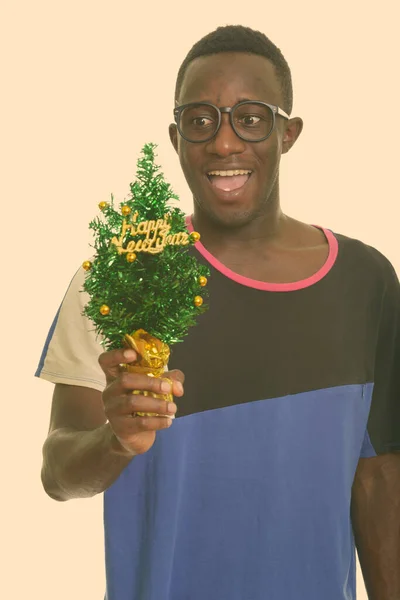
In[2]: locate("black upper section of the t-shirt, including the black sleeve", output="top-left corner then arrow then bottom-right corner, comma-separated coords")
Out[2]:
170,234 -> 400,451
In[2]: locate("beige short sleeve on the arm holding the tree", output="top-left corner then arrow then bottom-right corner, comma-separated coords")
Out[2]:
35,268 -> 106,392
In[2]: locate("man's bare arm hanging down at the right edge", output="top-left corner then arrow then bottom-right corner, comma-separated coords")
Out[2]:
351,454 -> 400,600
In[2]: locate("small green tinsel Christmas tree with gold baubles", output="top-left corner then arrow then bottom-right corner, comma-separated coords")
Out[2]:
83,144 -> 209,350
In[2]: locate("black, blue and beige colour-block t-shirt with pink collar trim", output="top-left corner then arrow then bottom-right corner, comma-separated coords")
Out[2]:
37,220 -> 400,600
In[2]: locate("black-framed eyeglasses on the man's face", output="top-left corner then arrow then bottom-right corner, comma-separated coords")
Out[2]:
174,100 -> 290,144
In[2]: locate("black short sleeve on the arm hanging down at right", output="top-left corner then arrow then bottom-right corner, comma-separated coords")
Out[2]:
361,259 -> 400,458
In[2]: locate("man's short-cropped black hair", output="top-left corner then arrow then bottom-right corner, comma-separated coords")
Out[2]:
175,25 -> 293,115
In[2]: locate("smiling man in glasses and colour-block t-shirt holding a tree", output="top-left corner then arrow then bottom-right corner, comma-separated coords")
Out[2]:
37,26 -> 400,600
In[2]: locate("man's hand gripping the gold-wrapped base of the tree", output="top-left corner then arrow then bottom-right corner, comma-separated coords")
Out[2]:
99,349 -> 185,456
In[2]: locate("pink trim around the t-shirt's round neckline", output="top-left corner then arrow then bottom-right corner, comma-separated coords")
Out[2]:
186,216 -> 339,292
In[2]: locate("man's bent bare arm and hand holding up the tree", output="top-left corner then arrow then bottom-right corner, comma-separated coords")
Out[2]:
42,350 -> 183,501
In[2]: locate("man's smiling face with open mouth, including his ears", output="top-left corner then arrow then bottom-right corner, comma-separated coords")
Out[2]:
170,53 -> 302,227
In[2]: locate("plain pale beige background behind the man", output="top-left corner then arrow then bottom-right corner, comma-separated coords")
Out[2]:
0,0 -> 400,600
